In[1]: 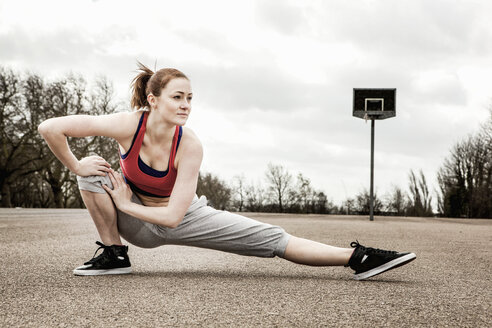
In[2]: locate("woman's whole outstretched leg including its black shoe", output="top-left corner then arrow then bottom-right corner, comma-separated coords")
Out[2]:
162,198 -> 416,280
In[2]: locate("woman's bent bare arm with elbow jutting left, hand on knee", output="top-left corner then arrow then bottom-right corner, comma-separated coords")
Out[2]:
38,113 -> 133,176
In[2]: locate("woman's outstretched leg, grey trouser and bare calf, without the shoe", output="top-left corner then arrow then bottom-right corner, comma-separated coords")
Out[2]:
160,198 -> 354,266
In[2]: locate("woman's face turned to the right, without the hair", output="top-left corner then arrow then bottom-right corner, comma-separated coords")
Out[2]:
149,78 -> 193,126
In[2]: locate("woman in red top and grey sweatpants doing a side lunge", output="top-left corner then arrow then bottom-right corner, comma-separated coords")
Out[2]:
39,63 -> 416,280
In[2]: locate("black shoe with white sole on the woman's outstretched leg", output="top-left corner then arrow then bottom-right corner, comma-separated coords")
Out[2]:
346,241 -> 417,280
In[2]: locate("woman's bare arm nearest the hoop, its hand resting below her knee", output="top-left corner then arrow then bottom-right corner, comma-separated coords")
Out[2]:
103,133 -> 203,228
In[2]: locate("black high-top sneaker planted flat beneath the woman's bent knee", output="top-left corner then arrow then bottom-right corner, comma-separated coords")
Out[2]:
73,241 -> 132,276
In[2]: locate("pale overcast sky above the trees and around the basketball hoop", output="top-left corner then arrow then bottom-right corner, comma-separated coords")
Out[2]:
0,0 -> 492,203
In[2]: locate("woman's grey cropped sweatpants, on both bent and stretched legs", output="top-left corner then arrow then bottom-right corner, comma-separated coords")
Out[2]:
77,176 -> 290,257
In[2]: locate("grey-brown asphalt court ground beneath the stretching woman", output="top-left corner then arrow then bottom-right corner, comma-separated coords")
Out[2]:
0,209 -> 492,327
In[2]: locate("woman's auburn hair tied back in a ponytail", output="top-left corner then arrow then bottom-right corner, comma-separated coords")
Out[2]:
130,61 -> 189,109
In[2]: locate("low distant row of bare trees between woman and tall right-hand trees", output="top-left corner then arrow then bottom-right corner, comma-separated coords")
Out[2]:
197,163 -> 435,216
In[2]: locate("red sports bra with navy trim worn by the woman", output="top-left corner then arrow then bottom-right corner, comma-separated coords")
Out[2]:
120,111 -> 183,197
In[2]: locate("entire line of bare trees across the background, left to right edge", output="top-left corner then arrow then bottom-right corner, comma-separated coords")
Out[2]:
0,66 -> 492,218
